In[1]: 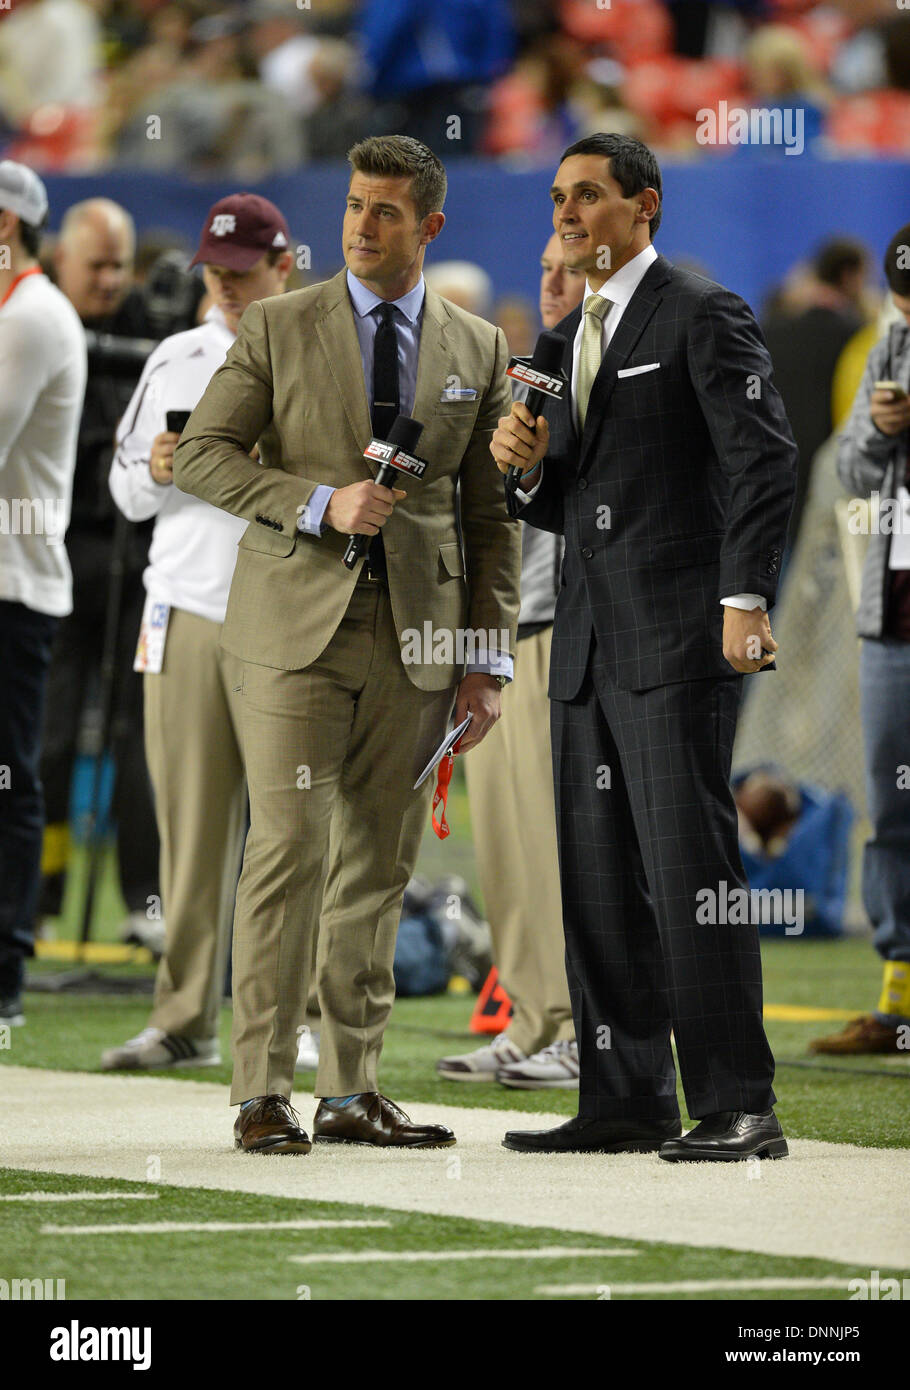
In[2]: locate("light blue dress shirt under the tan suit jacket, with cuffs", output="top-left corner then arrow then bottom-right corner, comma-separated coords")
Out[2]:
297,271 -> 513,680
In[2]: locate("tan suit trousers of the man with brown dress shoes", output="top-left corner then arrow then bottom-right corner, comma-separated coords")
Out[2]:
231,582 -> 454,1105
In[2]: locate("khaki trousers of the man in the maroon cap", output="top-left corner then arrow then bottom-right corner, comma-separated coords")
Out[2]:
143,609 -> 246,1038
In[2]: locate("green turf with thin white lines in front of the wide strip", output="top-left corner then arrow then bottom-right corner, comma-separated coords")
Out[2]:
0,1158 -> 906,1304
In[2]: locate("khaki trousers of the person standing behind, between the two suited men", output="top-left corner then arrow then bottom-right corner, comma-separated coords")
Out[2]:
464,627 -> 575,1052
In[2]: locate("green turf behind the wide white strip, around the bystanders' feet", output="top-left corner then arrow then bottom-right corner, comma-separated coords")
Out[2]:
0,938 -> 910,1148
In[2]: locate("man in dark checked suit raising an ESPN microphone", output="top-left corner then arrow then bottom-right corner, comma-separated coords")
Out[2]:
490,135 -> 796,1159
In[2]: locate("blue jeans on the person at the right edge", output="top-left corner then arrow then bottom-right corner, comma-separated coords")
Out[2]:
860,638 -> 910,1024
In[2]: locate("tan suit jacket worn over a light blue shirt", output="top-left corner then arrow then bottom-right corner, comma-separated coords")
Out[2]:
174,271 -> 521,691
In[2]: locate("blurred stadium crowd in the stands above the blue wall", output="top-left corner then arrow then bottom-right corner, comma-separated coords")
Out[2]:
0,0 -> 910,179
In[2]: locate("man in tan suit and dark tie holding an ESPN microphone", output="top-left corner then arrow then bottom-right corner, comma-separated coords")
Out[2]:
174,136 -> 520,1154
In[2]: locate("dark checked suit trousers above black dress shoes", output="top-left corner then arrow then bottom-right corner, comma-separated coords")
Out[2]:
552,646 -> 774,1119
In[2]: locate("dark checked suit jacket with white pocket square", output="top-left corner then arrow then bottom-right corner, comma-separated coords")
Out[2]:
510,256 -> 796,701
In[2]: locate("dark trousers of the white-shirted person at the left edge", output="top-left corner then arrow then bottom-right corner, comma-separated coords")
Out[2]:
0,599 -> 60,998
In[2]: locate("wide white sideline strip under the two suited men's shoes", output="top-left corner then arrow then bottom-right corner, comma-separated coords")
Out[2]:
0,1063 -> 910,1269
